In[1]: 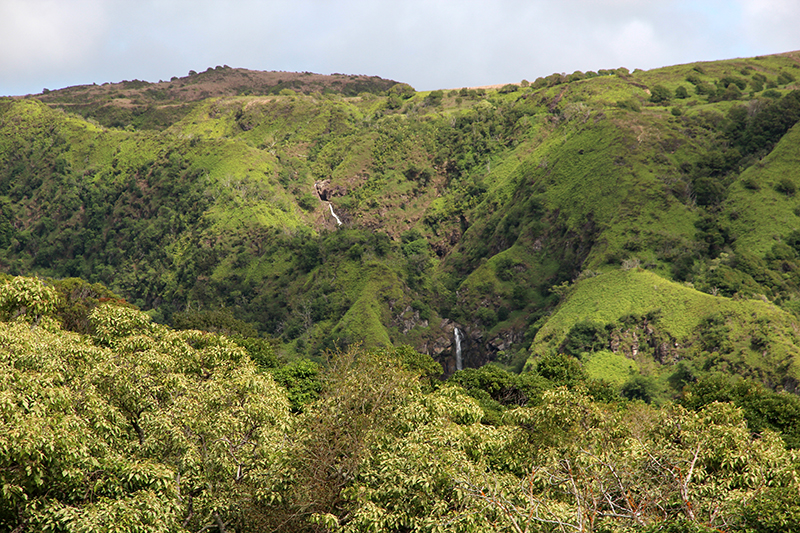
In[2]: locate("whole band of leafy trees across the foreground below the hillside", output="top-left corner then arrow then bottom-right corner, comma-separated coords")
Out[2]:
0,277 -> 800,533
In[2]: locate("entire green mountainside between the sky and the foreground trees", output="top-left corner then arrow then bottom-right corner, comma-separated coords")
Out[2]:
0,53 -> 800,394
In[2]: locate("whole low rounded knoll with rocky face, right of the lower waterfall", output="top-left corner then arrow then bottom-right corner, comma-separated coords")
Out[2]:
532,269 -> 800,387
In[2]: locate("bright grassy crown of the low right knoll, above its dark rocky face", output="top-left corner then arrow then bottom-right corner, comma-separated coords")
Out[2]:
531,269 -> 800,384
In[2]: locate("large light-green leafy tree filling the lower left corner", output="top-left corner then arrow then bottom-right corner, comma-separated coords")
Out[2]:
0,279 -> 288,532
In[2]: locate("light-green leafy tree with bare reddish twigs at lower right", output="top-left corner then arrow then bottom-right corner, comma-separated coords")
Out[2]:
463,389 -> 800,533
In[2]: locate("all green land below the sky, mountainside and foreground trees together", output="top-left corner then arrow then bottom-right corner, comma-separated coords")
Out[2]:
0,53 -> 800,533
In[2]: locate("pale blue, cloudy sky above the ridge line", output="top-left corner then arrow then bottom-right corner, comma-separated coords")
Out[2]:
0,0 -> 800,95
